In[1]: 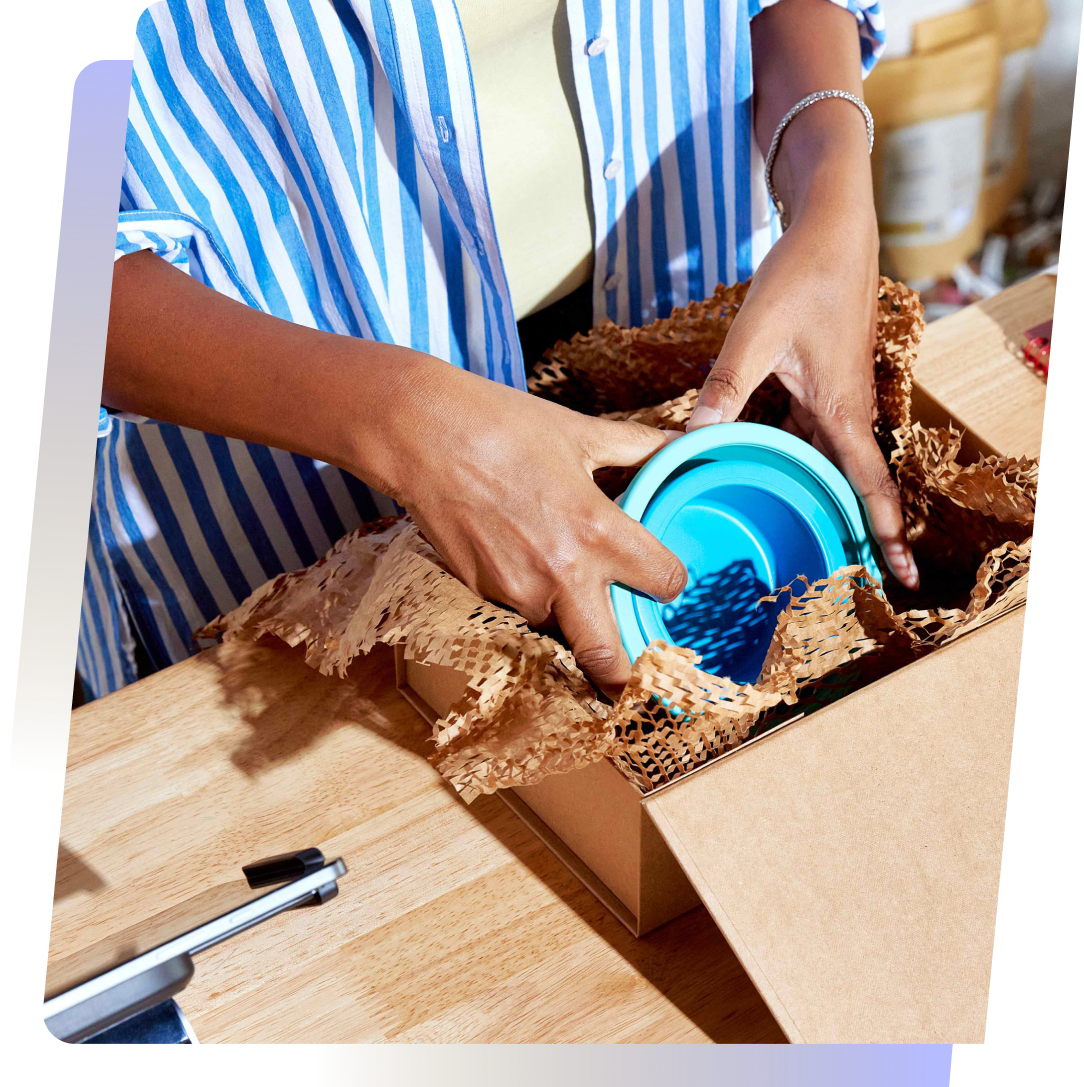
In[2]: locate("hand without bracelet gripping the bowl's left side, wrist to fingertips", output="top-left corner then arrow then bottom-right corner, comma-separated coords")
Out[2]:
353,352 -> 686,697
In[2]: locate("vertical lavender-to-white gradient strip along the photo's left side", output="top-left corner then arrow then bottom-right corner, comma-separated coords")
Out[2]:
8,60 -> 132,776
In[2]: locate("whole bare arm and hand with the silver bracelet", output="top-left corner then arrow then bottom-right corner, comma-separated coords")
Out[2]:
688,0 -> 919,589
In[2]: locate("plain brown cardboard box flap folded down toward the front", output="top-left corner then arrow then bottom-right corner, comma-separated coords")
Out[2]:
645,608 -> 1026,1042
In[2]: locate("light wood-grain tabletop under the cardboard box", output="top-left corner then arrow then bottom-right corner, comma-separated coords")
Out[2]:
46,277 -> 1056,1044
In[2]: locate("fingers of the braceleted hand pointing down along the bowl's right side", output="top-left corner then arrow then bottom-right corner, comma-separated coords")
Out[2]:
813,405 -> 919,589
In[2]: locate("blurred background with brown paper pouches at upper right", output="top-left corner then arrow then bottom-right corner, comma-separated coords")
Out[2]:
865,0 -> 1084,321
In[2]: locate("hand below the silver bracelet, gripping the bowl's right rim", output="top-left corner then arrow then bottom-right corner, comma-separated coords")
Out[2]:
688,191 -> 919,589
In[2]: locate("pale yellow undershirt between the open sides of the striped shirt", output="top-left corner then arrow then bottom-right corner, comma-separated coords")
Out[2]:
457,0 -> 594,320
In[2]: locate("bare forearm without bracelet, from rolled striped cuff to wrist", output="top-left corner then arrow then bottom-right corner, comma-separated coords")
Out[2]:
102,252 -> 426,489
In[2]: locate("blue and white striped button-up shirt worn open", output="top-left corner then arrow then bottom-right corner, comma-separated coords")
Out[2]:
77,0 -> 884,697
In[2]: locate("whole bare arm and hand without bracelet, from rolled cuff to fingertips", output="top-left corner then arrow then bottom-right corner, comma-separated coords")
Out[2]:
102,252 -> 685,695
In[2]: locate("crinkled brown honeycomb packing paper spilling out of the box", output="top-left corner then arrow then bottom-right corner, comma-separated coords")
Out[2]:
197,273 -> 1038,801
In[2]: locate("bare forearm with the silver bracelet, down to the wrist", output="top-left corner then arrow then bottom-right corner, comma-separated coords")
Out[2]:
750,0 -> 876,233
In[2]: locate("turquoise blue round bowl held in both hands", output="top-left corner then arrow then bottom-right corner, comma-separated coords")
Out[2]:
610,423 -> 881,683
